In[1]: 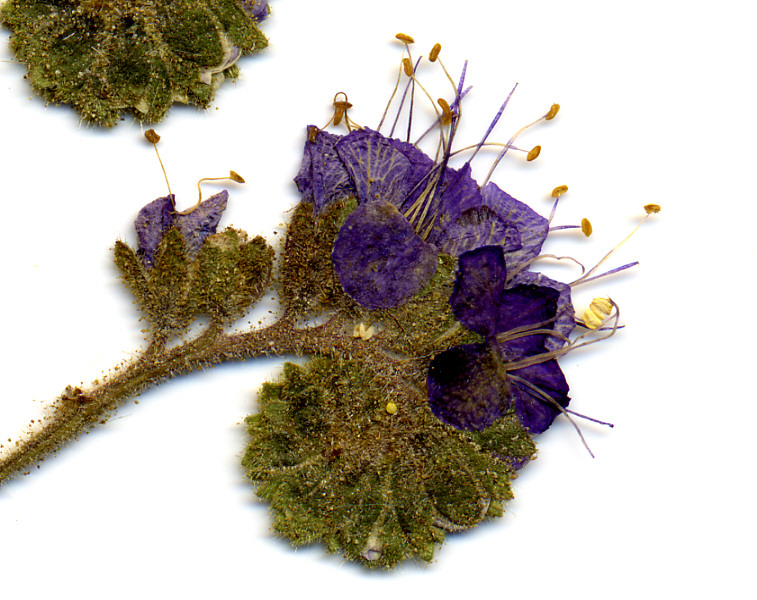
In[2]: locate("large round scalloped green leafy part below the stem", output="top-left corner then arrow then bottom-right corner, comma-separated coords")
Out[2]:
243,357 -> 535,568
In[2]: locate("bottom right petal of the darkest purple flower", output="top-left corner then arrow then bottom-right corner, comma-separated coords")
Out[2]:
510,360 -> 570,433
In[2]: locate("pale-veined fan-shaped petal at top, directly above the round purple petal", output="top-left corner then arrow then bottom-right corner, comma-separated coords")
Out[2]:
336,129 -> 430,208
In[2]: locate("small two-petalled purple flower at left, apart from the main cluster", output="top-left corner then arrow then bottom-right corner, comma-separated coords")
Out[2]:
134,190 -> 229,269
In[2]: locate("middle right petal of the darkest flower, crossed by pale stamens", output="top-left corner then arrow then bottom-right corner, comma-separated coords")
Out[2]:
497,285 -> 559,360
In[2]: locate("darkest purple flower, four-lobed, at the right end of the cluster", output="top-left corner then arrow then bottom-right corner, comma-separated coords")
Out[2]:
427,246 -> 574,433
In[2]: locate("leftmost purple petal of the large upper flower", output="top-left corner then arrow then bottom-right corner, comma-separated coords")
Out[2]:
294,125 -> 356,215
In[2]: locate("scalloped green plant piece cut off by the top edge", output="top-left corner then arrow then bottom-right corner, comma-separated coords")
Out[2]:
0,0 -> 268,127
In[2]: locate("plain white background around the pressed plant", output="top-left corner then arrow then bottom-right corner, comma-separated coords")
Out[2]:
0,0 -> 757,599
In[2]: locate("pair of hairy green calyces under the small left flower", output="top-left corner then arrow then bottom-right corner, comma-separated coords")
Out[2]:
114,227 -> 273,339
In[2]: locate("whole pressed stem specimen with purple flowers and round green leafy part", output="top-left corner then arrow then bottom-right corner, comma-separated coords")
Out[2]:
0,36 -> 654,568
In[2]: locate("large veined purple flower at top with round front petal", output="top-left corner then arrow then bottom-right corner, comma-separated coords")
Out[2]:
295,128 -> 549,308
